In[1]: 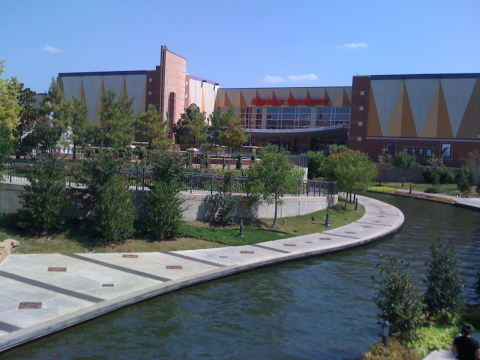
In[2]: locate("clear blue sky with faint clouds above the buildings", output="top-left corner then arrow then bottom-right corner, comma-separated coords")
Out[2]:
0,0 -> 480,92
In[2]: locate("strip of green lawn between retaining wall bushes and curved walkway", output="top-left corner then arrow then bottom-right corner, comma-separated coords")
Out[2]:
0,202 -> 365,254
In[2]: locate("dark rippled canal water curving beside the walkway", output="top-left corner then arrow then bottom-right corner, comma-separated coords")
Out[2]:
0,195 -> 480,360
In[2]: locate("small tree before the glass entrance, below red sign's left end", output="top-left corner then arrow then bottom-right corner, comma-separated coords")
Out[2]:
217,108 -> 248,149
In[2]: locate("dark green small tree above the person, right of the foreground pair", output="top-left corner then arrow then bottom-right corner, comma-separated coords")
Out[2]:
425,241 -> 463,316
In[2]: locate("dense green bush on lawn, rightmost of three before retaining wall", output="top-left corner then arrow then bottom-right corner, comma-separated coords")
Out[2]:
143,181 -> 183,240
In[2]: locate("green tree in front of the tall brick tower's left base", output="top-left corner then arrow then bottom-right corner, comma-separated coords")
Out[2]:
135,104 -> 172,150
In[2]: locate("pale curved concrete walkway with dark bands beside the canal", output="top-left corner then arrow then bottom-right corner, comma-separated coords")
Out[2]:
0,196 -> 404,352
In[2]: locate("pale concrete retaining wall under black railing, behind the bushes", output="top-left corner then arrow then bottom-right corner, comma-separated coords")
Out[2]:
0,183 -> 338,220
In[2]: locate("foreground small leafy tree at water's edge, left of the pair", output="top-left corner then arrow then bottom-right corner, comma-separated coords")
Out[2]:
374,257 -> 423,343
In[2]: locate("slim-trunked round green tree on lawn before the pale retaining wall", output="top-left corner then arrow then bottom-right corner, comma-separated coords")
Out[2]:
248,153 -> 302,227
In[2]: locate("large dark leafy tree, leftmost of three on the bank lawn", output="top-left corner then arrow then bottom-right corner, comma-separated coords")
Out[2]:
19,156 -> 68,233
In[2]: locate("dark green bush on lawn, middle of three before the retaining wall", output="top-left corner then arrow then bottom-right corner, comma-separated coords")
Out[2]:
94,175 -> 135,242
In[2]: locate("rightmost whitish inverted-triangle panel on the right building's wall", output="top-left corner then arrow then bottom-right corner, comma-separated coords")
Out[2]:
442,78 -> 476,135
